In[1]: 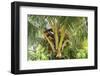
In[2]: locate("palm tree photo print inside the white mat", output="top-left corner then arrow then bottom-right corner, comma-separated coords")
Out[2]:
27,15 -> 88,60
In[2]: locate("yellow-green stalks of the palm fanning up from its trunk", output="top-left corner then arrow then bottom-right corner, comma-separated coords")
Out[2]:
44,18 -> 69,59
